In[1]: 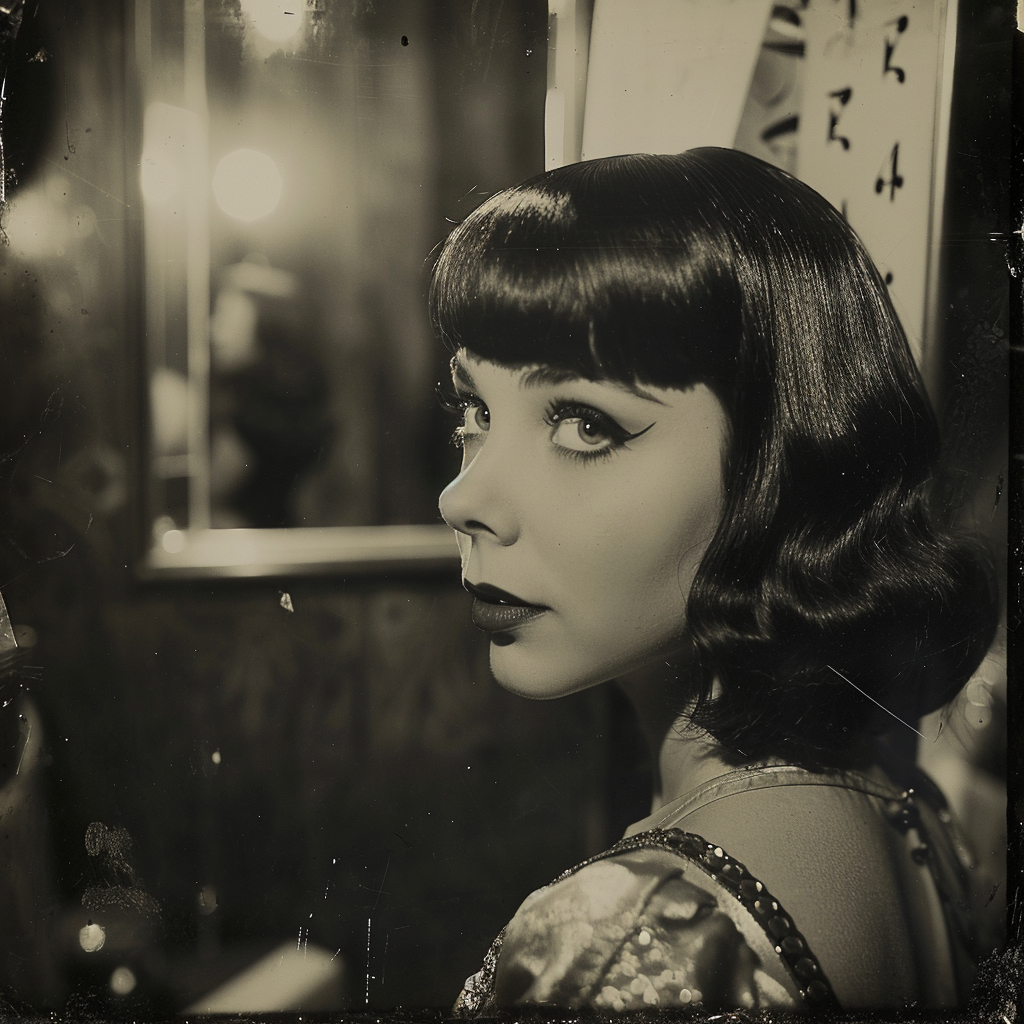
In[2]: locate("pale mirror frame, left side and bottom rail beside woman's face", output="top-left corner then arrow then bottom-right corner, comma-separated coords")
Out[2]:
133,0 -> 460,581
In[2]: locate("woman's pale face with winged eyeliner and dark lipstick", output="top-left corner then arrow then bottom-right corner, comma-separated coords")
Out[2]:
440,350 -> 727,698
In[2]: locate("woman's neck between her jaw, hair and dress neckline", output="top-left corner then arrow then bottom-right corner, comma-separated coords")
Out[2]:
618,662 -> 734,812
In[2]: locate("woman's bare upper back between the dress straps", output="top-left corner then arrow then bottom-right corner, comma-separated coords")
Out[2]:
680,785 -> 918,1008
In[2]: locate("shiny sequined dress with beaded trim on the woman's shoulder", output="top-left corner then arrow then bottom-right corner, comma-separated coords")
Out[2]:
455,765 -> 975,1018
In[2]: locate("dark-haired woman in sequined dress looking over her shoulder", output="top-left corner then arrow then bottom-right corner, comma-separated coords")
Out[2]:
430,150 -> 995,1015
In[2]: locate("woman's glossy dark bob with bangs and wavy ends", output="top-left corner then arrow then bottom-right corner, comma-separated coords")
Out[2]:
430,148 -> 996,767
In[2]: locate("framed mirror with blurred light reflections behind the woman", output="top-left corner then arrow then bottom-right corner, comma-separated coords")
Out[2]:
140,0 -> 547,577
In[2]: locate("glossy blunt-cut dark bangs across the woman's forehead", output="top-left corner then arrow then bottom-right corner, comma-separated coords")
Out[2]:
430,157 -> 742,400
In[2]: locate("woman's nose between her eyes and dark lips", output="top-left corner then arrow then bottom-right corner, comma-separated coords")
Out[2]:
438,437 -> 519,547
